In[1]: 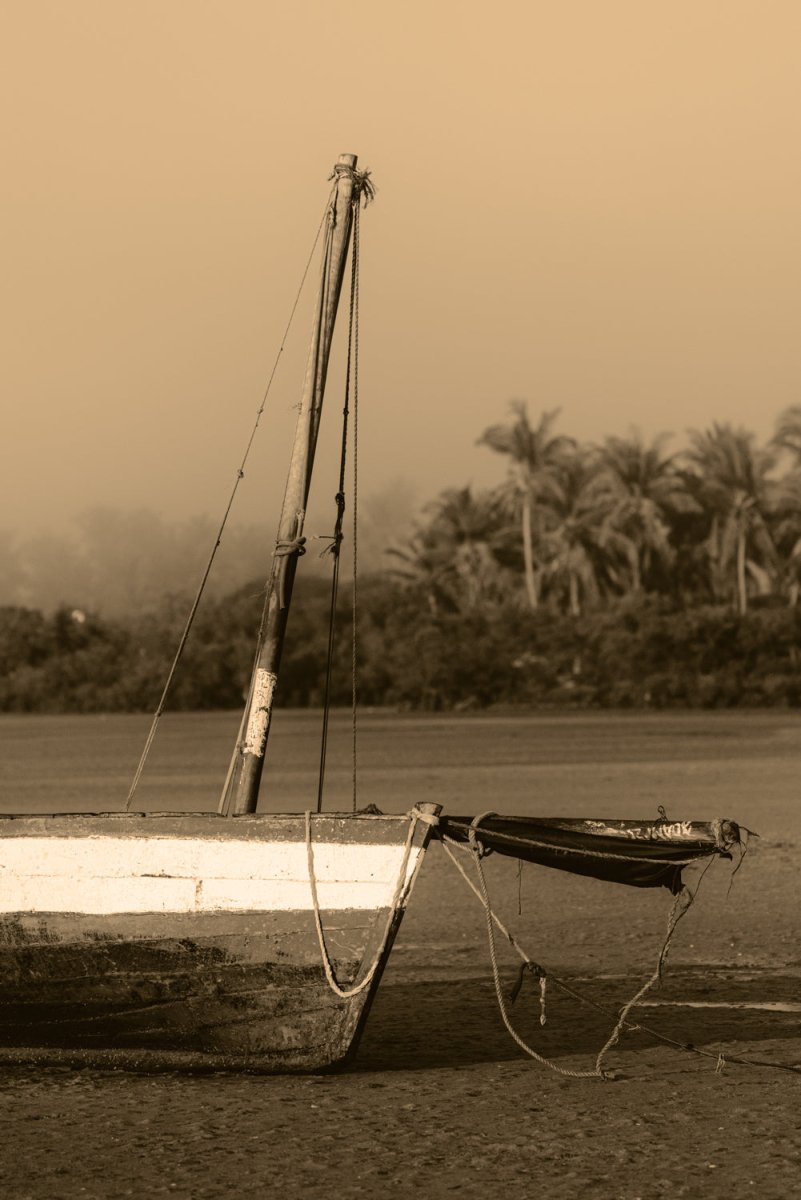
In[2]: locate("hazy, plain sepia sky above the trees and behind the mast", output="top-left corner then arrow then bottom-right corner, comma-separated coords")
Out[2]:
0,0 -> 801,534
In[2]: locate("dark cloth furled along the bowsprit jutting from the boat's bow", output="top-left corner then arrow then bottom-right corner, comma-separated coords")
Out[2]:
439,814 -> 741,895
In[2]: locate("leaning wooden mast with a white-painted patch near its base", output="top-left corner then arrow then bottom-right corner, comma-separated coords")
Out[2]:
225,154 -> 360,816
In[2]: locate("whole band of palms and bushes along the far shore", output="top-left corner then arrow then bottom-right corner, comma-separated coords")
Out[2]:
0,404 -> 801,712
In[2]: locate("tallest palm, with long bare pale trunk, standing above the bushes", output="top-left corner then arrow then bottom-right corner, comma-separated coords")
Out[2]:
478,400 -> 576,608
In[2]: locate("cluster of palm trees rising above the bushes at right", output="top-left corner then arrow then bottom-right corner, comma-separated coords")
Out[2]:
399,403 -> 801,617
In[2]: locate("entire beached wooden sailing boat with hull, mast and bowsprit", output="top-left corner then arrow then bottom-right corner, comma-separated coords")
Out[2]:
0,155 -> 740,1072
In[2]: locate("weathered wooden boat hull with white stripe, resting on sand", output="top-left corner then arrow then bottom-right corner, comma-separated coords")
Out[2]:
0,812 -> 430,1072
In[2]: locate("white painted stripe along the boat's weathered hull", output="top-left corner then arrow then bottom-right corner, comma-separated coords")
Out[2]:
0,838 -> 421,913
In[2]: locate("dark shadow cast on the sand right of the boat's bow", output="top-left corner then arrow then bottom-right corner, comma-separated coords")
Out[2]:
350,968 -> 801,1072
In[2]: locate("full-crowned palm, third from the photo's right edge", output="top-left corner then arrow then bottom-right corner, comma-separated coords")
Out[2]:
598,431 -> 693,593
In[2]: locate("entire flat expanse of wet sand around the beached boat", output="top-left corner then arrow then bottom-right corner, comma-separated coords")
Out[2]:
0,713 -> 801,1200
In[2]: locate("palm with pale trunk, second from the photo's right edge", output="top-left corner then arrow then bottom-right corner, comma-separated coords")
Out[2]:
685,422 -> 777,614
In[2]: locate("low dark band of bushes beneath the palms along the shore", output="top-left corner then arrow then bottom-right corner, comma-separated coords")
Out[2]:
0,590 -> 801,712
